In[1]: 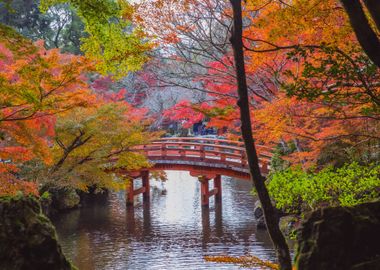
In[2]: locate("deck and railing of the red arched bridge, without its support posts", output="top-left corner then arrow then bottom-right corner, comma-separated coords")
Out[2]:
140,137 -> 271,179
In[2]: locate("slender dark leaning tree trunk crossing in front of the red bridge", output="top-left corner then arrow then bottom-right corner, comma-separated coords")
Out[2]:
230,0 -> 292,270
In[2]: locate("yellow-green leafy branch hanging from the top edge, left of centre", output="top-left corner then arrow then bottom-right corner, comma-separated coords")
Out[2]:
41,0 -> 152,77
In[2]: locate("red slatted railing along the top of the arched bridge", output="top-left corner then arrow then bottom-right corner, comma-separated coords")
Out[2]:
134,137 -> 272,170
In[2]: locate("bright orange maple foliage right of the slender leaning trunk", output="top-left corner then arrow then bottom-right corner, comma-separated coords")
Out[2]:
238,1 -> 379,167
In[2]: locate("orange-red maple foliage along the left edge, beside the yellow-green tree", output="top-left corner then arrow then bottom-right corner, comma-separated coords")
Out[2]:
0,26 -> 90,196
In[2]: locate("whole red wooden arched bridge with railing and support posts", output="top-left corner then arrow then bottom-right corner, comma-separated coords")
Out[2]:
127,137 -> 272,206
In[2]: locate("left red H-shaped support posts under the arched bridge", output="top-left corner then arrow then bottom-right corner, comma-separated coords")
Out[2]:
126,170 -> 150,206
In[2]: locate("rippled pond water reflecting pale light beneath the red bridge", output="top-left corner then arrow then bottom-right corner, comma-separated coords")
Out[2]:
53,171 -> 275,270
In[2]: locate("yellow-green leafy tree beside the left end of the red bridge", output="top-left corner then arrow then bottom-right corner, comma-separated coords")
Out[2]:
39,101 -> 151,190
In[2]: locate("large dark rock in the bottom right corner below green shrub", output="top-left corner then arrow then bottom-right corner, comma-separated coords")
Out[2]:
296,202 -> 380,270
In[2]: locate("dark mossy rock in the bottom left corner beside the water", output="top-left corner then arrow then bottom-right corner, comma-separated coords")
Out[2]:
0,196 -> 75,270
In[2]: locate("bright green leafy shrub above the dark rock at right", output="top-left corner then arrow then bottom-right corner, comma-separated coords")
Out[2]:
268,162 -> 380,213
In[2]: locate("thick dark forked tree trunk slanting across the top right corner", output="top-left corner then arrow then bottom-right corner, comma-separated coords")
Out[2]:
341,0 -> 380,67
